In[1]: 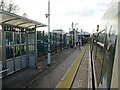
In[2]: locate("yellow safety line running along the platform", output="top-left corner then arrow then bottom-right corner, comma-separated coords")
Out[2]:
56,45 -> 88,88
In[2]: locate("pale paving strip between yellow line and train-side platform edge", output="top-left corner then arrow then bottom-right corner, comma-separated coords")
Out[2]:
72,48 -> 89,89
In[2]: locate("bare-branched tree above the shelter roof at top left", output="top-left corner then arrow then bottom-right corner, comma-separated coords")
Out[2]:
0,0 -> 20,13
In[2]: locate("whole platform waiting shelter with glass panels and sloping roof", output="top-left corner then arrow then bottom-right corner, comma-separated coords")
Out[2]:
0,11 -> 46,76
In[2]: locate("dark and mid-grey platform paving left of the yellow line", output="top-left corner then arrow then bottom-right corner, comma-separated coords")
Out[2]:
2,48 -> 79,88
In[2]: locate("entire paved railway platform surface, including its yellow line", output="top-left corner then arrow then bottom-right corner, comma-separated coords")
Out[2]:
2,44 -> 92,89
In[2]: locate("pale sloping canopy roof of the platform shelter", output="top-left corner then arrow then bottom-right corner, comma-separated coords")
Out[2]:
0,10 -> 47,29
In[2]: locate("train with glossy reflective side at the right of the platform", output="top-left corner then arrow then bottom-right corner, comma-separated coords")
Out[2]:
91,1 -> 120,90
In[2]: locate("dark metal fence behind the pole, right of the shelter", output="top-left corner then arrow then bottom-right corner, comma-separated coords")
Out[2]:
37,31 -> 70,58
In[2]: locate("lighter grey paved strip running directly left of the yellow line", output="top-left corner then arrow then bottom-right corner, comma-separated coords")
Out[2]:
30,49 -> 80,88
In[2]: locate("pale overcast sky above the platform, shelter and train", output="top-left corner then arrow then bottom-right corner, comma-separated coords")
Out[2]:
9,0 -> 111,32
